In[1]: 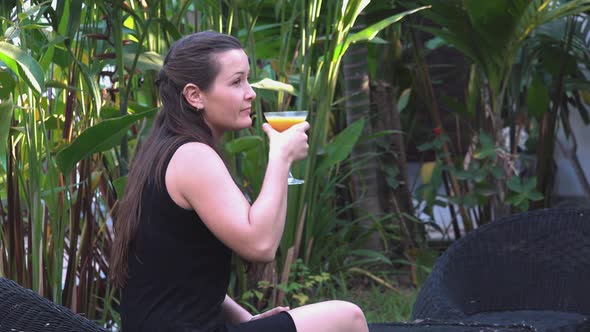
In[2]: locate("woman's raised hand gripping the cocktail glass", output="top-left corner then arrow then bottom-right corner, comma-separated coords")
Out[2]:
262,121 -> 309,163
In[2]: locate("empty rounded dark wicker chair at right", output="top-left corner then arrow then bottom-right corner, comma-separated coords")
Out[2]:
412,209 -> 590,331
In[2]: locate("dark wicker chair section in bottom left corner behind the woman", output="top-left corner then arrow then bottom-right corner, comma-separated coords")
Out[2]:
0,278 -> 107,332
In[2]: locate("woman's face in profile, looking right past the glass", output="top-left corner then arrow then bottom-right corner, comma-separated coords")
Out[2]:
202,49 -> 256,139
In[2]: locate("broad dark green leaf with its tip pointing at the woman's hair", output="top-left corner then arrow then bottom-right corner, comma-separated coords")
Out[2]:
55,109 -> 157,174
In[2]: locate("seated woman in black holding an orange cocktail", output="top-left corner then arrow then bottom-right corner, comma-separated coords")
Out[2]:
111,31 -> 368,332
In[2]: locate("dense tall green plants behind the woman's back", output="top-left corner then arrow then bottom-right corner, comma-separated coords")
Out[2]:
0,0 -> 199,324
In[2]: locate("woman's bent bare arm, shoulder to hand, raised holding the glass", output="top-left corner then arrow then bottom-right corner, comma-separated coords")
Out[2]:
166,122 -> 309,262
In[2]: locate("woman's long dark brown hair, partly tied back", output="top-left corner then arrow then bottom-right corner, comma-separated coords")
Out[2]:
110,31 -> 242,288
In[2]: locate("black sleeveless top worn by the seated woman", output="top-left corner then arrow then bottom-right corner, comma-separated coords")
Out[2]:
121,142 -> 231,332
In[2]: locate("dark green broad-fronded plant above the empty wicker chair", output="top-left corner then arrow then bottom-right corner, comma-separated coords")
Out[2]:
402,0 -> 590,231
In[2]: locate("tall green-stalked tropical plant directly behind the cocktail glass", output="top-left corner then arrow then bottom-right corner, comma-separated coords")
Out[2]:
226,1 -> 430,305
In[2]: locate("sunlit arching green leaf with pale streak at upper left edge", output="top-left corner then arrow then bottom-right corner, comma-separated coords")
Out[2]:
0,41 -> 45,93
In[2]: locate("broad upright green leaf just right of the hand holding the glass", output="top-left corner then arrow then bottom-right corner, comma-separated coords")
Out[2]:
318,118 -> 365,171
